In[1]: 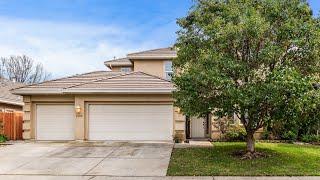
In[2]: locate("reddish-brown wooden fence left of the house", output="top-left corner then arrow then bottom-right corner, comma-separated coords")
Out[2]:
0,112 -> 23,140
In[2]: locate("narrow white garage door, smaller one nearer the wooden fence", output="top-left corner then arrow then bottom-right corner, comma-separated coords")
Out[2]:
36,105 -> 75,140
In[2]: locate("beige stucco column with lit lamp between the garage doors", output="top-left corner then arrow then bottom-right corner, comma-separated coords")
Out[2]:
74,96 -> 85,140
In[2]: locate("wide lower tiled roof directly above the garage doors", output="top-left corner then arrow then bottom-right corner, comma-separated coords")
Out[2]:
14,71 -> 174,95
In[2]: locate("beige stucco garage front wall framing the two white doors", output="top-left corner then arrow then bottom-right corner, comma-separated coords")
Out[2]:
23,94 -> 185,140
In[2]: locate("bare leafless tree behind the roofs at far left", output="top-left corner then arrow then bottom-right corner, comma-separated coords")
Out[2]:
0,55 -> 51,84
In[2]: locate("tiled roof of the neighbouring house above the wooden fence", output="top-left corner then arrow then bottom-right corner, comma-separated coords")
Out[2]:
0,78 -> 23,106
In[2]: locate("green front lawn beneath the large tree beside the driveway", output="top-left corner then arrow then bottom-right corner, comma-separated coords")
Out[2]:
167,142 -> 320,176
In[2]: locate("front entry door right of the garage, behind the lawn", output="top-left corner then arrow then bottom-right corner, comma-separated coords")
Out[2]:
190,117 -> 206,138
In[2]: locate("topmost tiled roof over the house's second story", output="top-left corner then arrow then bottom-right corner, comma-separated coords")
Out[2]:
127,47 -> 177,59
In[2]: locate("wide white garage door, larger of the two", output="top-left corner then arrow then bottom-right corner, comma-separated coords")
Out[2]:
89,105 -> 173,140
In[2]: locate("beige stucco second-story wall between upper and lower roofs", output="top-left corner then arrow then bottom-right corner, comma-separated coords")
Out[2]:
133,60 -> 167,78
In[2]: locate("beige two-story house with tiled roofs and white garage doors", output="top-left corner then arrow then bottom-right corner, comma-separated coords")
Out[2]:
14,48 -> 211,140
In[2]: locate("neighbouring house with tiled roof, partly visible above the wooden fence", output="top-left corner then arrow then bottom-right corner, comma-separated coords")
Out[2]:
0,78 -> 23,112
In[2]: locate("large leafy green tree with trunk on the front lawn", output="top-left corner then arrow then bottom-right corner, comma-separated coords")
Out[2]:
173,0 -> 320,154
